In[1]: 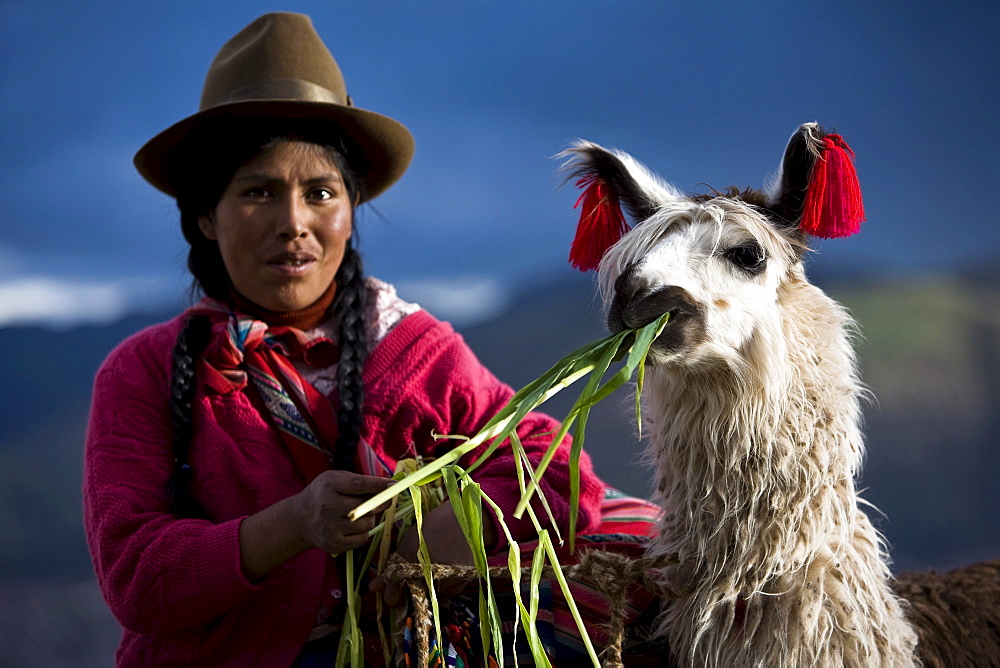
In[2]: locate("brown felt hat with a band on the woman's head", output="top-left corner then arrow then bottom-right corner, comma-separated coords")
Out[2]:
134,12 -> 413,199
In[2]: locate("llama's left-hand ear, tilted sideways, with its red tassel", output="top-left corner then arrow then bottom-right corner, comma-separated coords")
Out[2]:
557,140 -> 682,271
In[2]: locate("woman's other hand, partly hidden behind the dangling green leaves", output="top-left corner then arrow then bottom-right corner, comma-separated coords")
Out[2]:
369,500 -> 496,607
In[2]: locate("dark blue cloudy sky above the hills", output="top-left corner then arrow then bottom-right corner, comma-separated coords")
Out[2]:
0,0 -> 1000,326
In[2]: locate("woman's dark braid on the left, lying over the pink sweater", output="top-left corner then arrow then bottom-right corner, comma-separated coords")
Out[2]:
167,316 -> 211,519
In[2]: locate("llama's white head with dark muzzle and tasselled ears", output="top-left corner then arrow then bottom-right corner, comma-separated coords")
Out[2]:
565,123 -> 860,368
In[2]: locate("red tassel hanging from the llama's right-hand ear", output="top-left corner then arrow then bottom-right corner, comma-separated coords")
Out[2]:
799,135 -> 865,239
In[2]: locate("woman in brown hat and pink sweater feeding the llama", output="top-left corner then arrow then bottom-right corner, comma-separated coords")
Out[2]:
84,13 -> 603,666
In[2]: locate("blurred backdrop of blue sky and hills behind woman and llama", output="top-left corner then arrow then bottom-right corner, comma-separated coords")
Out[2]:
0,0 -> 1000,666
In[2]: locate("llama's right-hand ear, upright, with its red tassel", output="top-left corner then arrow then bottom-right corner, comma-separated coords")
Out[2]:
766,123 -> 865,238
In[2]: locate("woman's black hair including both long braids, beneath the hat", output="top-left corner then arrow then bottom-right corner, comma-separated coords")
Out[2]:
168,122 -> 368,517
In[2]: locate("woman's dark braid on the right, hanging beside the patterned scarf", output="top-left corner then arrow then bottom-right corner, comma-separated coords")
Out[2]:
333,245 -> 368,469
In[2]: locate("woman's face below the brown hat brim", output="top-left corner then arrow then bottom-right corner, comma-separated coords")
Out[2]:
198,141 -> 354,311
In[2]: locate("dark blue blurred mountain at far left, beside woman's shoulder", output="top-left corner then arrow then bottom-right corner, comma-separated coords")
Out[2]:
0,314 -> 183,580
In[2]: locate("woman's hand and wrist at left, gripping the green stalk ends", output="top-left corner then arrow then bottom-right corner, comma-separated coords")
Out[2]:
240,471 -> 394,580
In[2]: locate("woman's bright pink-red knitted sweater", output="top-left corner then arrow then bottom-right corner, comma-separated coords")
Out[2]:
84,311 -> 604,666
